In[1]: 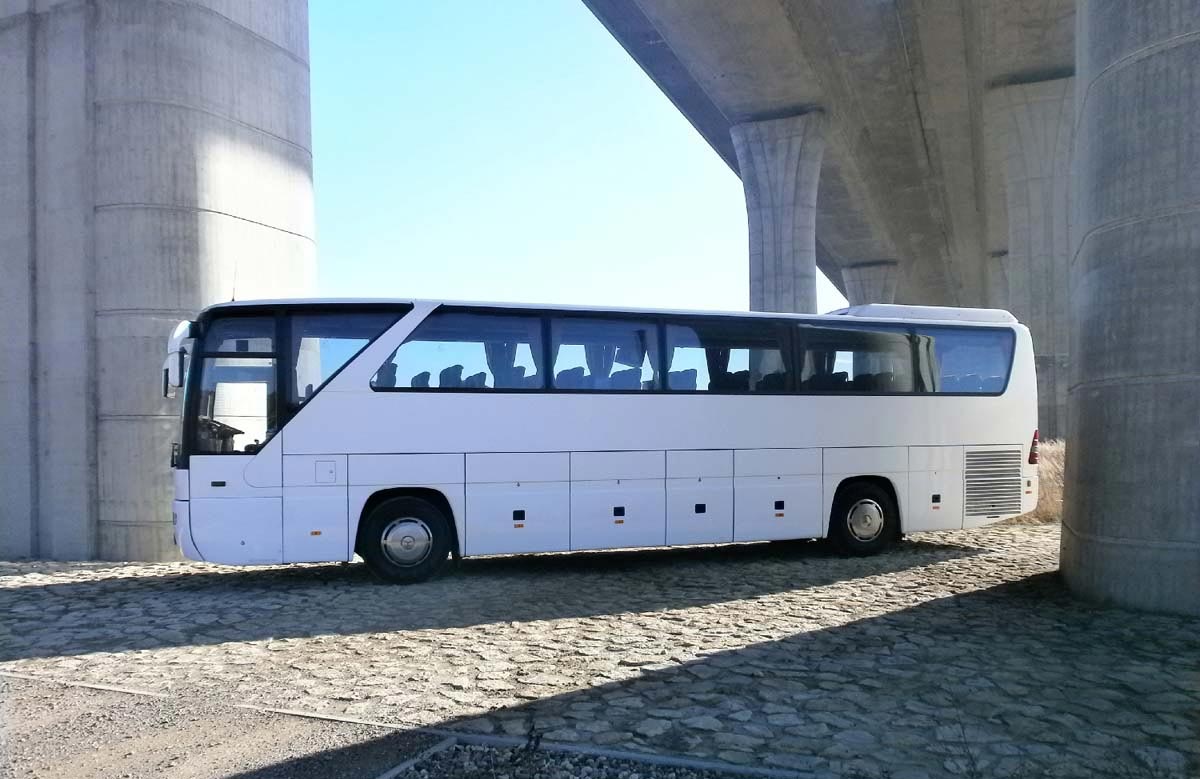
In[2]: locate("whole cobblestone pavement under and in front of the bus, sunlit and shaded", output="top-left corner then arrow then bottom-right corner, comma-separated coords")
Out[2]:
0,526 -> 1200,779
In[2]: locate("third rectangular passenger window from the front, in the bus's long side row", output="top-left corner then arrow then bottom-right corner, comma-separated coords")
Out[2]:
666,318 -> 791,393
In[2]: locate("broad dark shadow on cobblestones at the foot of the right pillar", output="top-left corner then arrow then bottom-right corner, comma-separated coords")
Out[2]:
218,574 -> 1200,779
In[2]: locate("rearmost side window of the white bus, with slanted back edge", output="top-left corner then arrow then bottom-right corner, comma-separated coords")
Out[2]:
917,328 -> 1015,395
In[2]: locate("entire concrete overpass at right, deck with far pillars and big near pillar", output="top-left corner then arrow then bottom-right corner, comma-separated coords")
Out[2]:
583,0 -> 1200,613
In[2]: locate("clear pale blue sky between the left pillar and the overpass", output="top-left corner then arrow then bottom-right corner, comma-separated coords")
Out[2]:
310,0 -> 844,311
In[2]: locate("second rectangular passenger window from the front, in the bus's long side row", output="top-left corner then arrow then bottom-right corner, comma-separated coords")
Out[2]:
551,317 -> 659,393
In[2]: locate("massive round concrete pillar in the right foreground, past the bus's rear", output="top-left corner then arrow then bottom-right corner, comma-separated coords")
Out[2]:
1062,0 -> 1200,616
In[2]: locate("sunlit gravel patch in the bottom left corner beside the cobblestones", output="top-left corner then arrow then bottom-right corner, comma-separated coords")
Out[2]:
0,678 -> 437,779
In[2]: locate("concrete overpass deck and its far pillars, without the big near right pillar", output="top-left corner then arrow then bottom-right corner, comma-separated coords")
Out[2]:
584,0 -> 1075,436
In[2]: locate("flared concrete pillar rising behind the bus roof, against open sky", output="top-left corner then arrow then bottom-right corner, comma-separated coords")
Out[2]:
730,112 -> 826,313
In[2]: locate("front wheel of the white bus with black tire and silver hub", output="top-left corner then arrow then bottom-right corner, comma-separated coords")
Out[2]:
359,498 -> 454,585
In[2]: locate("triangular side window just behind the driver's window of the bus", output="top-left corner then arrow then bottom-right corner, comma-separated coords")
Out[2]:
289,312 -> 400,407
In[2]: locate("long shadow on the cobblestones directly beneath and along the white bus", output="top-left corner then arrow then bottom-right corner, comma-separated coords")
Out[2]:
0,540 -> 982,661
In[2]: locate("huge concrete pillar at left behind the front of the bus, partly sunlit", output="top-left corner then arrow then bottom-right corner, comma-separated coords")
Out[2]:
0,0 -> 314,559
